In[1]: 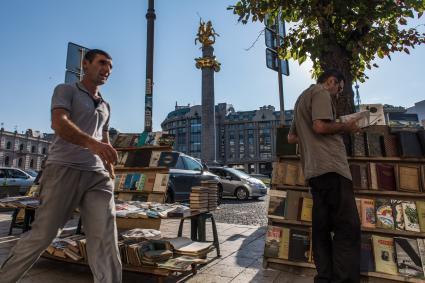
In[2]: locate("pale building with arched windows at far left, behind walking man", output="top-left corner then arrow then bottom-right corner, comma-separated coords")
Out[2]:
0,128 -> 52,170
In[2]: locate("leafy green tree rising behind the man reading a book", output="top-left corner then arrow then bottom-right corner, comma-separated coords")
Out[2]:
228,0 -> 425,115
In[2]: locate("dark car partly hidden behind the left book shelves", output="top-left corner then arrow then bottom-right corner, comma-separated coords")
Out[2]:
166,152 -> 223,202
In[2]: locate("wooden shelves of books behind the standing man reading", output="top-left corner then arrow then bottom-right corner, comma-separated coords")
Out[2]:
264,125 -> 425,282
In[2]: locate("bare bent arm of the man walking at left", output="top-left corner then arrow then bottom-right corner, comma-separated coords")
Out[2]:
52,108 -> 117,164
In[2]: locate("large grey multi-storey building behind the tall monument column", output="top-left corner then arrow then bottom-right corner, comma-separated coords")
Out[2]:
161,103 -> 293,175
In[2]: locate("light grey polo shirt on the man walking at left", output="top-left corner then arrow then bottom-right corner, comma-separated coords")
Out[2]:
47,82 -> 110,171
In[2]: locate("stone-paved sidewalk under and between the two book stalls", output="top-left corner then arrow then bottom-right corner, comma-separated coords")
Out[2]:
0,212 -> 313,283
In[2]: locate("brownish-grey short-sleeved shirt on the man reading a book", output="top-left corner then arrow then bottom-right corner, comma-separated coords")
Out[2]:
290,84 -> 351,180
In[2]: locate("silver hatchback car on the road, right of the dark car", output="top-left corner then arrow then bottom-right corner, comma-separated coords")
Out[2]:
209,167 -> 267,200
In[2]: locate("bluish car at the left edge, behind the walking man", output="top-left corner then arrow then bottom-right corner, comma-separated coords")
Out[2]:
0,167 -> 35,193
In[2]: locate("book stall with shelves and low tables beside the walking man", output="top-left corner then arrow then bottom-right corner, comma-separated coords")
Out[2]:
0,132 -> 220,282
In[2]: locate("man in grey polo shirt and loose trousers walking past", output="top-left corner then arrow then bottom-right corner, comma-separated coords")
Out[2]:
0,49 -> 122,283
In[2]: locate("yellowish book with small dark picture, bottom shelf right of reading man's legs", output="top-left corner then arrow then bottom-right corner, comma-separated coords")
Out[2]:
372,235 -> 398,275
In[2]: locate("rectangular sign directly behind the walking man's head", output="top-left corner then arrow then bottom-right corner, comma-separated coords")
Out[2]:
65,42 -> 90,83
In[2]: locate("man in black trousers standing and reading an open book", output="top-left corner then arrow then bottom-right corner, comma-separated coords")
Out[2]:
288,70 -> 360,283
